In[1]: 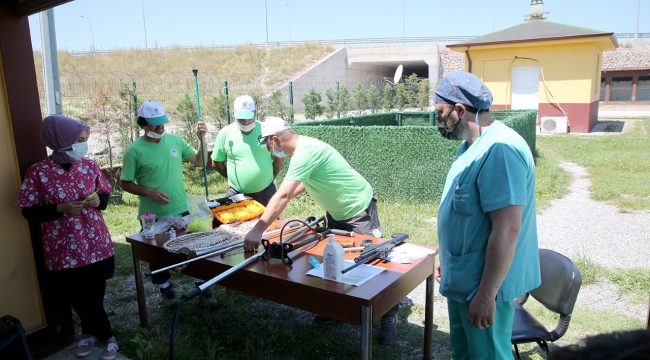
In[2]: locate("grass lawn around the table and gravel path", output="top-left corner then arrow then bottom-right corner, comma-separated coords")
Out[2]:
97,120 -> 650,360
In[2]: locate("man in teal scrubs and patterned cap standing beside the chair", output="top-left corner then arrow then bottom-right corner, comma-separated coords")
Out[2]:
435,71 -> 541,360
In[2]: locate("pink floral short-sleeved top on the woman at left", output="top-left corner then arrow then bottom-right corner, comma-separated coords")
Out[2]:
16,158 -> 115,270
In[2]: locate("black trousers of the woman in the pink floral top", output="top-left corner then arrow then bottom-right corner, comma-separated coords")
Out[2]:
48,256 -> 115,341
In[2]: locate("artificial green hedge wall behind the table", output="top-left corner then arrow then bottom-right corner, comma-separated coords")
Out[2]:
279,110 -> 537,203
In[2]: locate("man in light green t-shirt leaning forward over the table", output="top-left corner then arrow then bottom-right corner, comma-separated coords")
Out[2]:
244,117 -> 399,344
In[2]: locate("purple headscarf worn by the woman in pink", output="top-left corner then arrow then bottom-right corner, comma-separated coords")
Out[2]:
41,115 -> 90,164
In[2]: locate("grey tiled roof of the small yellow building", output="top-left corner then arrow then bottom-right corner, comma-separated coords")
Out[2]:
449,20 -> 614,47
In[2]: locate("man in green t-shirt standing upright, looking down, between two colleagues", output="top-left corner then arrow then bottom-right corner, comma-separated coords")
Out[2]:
212,95 -> 284,206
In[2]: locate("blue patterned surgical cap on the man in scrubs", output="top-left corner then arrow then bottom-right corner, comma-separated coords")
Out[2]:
435,71 -> 492,110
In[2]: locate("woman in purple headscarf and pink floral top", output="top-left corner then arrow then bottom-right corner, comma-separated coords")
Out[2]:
16,115 -> 118,360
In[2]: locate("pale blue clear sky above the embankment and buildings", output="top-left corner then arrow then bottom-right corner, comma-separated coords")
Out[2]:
29,0 -> 650,51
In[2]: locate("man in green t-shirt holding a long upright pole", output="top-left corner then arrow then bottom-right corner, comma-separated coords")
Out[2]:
120,101 -> 217,309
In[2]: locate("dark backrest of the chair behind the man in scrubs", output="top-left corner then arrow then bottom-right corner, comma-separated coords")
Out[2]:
530,249 -> 582,315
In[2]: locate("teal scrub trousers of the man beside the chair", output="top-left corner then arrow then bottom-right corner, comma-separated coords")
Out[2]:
447,299 -> 515,360
